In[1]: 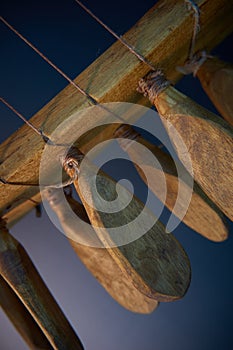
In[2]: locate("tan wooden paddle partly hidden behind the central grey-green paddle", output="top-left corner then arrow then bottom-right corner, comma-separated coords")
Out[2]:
44,188 -> 158,314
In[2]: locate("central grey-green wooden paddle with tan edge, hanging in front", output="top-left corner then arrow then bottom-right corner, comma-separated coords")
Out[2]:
62,148 -> 190,301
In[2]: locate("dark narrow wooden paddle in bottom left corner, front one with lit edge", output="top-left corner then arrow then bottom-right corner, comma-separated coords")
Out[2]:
0,220 -> 83,350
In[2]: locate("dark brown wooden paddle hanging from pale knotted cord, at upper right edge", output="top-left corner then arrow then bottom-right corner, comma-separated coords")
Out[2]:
197,57 -> 233,126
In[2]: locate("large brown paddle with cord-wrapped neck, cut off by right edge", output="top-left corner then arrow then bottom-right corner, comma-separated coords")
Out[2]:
138,71 -> 233,220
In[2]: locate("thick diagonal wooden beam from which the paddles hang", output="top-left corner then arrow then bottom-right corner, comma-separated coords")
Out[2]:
0,0 -> 233,225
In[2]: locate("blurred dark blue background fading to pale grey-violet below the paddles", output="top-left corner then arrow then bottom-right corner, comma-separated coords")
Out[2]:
0,0 -> 233,350
